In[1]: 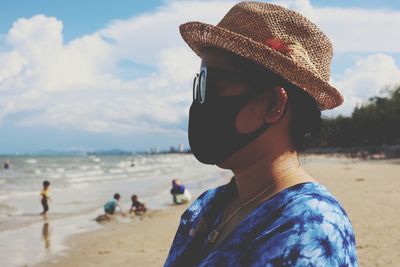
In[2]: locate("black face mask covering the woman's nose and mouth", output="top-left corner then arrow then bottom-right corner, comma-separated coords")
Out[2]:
189,94 -> 270,164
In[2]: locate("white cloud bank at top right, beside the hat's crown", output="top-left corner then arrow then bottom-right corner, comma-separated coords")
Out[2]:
275,0 -> 400,53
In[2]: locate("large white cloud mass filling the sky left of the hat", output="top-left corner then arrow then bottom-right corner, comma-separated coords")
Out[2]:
0,1 -> 238,134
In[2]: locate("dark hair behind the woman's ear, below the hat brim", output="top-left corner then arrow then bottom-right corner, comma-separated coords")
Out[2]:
284,82 -> 322,152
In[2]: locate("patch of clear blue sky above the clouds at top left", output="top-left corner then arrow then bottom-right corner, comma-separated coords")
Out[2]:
0,0 -> 163,42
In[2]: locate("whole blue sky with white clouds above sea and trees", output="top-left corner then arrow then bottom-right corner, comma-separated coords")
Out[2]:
0,0 -> 400,154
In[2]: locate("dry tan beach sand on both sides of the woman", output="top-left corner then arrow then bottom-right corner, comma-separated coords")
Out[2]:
37,157 -> 400,267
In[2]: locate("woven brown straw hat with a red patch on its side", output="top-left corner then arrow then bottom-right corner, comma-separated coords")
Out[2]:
180,2 -> 343,110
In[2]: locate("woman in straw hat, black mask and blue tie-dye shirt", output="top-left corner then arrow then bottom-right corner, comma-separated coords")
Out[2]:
165,2 -> 358,266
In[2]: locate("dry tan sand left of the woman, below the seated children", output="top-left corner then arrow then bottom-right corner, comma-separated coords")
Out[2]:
34,205 -> 188,267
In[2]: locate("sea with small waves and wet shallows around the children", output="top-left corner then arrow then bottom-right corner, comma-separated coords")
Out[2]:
0,154 -> 232,266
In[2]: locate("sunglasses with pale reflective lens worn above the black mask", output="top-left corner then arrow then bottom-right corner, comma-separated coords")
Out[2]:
193,66 -> 272,104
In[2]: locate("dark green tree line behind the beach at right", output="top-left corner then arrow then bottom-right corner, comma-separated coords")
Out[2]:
313,86 -> 400,148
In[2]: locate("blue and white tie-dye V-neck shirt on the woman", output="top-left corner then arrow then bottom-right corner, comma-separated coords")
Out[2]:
165,180 -> 358,266
